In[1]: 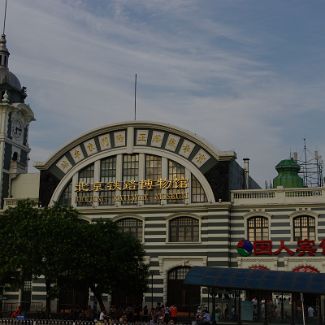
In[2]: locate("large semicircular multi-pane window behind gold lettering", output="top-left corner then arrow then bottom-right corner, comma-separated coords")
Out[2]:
58,153 -> 208,207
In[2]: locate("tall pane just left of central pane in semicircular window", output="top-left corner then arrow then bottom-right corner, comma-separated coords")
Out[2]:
99,156 -> 116,205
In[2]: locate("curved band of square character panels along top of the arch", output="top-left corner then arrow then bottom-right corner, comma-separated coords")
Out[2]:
36,121 -> 236,172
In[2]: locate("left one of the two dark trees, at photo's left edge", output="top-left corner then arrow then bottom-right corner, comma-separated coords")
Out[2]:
0,200 -> 80,312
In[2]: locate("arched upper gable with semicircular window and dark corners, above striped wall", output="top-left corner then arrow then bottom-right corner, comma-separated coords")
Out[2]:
37,122 -> 242,206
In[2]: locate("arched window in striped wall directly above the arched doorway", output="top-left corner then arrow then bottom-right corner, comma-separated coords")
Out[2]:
169,217 -> 199,242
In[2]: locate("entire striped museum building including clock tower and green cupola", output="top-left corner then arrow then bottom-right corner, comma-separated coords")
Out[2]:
0,31 -> 325,310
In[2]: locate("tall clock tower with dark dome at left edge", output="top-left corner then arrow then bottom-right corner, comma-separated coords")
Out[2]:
0,34 -> 34,209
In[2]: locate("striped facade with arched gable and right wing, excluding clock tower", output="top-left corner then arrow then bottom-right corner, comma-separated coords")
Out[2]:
5,121 -> 325,314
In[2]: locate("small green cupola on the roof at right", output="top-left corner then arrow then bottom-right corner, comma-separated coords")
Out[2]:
273,158 -> 304,188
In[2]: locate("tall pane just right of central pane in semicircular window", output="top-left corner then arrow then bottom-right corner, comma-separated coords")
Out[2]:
144,155 -> 162,204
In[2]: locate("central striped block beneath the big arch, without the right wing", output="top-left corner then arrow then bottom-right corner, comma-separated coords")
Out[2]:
33,121 -> 244,305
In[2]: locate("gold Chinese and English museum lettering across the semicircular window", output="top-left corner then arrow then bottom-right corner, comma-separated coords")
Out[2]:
75,178 -> 189,203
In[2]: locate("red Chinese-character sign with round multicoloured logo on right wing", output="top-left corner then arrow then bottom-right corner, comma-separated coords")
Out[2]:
237,239 -> 325,257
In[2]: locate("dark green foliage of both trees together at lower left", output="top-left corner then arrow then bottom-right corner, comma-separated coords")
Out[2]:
0,200 -> 148,309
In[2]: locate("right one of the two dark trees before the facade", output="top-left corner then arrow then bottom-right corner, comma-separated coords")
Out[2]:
66,220 -> 148,311
